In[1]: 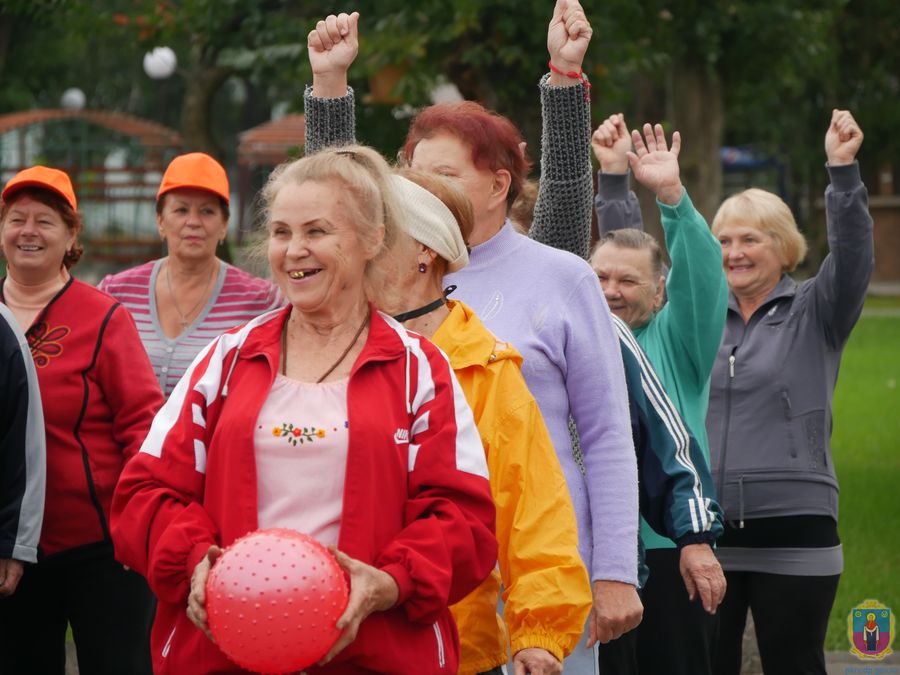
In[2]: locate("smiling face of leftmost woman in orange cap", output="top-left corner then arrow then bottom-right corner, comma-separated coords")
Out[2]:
0,194 -> 75,282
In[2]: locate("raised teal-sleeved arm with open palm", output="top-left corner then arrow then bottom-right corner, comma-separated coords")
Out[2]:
628,124 -> 728,382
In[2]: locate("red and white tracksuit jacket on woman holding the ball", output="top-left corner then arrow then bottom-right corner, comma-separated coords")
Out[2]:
111,306 -> 497,675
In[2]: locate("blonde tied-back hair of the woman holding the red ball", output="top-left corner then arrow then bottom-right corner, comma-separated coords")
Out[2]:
260,145 -> 400,257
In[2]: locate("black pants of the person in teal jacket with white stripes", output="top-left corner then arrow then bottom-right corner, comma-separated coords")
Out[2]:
599,548 -> 717,675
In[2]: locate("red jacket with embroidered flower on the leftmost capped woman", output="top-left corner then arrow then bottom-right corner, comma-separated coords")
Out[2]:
0,278 -> 163,558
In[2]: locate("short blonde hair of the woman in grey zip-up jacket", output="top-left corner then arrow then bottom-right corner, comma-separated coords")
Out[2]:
712,188 -> 806,272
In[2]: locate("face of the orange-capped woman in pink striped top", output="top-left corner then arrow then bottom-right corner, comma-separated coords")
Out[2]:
156,188 -> 228,260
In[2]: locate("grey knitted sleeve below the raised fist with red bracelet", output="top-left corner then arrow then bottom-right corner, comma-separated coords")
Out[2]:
529,73 -> 594,259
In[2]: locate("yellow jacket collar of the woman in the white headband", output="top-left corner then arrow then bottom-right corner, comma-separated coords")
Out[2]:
432,300 -> 522,370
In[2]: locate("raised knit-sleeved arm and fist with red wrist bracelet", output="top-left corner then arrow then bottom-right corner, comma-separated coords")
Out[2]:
529,0 -> 594,259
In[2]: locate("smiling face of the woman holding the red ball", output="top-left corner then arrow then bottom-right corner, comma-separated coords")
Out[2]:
268,181 -> 383,313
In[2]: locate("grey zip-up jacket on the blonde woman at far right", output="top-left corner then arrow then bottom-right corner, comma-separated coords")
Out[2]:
706,163 -> 874,524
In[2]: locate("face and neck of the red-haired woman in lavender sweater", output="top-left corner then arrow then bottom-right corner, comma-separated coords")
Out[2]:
410,132 -> 509,244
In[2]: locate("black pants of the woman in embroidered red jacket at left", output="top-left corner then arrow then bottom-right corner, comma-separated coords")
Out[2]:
0,545 -> 154,675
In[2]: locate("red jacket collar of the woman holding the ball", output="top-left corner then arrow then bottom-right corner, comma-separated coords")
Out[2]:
238,304 -> 406,375
